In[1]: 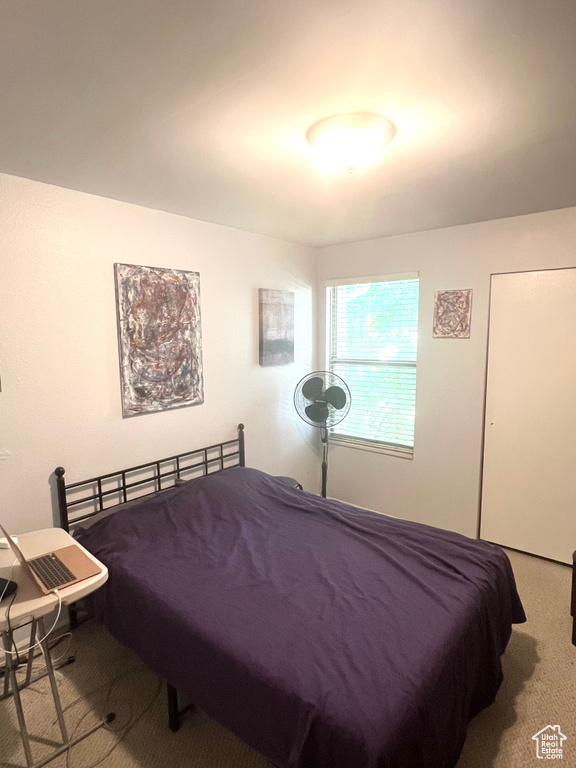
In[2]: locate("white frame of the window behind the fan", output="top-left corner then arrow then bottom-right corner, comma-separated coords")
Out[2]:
325,272 -> 420,459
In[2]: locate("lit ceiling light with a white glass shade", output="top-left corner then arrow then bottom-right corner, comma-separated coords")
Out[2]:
306,112 -> 396,173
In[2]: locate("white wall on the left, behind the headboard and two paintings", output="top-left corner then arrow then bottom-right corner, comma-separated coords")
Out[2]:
0,175 -> 318,533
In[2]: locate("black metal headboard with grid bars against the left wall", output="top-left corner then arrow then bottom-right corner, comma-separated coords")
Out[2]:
54,424 -> 245,531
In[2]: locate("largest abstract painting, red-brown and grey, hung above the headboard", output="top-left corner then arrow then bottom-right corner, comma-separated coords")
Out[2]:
114,264 -> 204,417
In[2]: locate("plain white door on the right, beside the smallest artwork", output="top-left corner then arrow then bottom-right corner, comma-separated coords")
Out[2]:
480,269 -> 576,563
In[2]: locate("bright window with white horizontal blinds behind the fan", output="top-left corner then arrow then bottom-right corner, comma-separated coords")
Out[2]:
327,273 -> 418,456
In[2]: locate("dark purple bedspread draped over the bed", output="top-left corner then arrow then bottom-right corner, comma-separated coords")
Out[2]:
80,467 -> 525,768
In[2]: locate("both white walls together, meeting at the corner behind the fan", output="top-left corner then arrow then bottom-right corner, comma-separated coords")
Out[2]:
0,175 -> 576,536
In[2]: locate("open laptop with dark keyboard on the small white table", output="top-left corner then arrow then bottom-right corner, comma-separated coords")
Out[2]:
0,525 -> 102,595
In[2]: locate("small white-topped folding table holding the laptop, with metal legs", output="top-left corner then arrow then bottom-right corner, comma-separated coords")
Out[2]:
0,528 -> 113,768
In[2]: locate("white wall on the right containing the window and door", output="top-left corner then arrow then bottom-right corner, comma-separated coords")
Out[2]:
318,208 -> 576,536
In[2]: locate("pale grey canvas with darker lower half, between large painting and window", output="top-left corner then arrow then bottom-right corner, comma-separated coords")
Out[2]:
258,288 -> 294,366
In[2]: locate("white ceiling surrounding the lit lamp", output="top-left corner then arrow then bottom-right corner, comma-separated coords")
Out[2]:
0,0 -> 576,246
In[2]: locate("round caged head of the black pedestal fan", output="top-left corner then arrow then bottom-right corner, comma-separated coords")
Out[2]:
294,371 -> 350,429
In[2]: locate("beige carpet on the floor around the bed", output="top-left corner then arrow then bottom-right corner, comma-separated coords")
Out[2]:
0,552 -> 576,768
